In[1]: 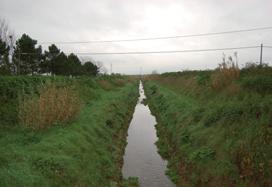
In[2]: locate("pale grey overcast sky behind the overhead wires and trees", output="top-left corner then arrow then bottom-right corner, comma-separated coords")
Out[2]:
0,0 -> 272,74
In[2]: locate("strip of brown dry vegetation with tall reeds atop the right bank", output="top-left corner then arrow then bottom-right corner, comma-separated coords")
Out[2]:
145,62 -> 241,96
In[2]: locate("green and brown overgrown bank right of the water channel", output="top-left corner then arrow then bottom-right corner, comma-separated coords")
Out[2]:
145,68 -> 272,187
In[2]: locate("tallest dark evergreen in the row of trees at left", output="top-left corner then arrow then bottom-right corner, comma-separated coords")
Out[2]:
13,34 -> 42,74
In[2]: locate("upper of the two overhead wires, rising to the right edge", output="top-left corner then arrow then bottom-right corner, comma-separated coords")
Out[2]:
40,26 -> 272,44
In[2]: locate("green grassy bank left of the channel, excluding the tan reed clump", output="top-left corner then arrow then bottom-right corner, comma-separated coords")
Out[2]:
0,77 -> 138,187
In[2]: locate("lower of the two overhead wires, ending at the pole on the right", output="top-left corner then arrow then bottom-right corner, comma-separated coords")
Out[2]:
74,46 -> 260,56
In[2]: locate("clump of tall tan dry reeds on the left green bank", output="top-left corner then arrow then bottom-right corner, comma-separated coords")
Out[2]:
18,83 -> 81,129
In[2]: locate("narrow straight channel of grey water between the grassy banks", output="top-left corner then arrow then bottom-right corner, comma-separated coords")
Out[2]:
122,82 -> 175,187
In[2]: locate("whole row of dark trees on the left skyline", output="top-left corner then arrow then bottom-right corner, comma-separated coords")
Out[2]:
0,20 -> 99,76
